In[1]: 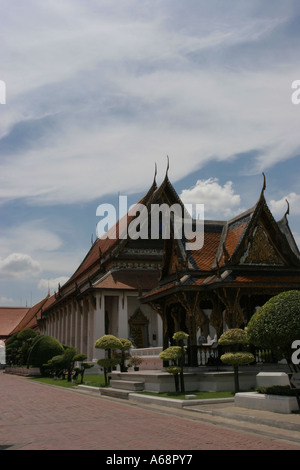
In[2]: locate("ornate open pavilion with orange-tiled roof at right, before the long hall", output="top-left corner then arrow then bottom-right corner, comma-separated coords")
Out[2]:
141,177 -> 300,366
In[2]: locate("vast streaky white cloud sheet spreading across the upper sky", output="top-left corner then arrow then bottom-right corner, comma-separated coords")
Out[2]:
0,1 -> 300,204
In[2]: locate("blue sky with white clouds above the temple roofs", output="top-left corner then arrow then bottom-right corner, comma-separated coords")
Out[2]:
0,0 -> 300,306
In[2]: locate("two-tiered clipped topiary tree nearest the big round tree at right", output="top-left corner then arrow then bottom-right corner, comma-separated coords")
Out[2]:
219,328 -> 254,393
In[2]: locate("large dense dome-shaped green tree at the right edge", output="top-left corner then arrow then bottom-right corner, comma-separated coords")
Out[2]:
247,290 -> 300,370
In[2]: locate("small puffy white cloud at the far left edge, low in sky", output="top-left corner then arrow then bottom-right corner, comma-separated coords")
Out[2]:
0,253 -> 41,278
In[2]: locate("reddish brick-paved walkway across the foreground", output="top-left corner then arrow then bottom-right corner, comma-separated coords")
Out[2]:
0,371 -> 300,453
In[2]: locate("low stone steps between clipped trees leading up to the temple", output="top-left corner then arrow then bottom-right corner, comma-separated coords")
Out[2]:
100,372 -> 145,399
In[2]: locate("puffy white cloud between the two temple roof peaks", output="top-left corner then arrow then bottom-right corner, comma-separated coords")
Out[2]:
180,178 -> 241,220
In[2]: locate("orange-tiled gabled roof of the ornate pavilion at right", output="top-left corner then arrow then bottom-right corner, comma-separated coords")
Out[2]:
141,174 -> 300,303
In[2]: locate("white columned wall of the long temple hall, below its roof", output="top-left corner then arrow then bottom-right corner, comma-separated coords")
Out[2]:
40,291 -> 162,360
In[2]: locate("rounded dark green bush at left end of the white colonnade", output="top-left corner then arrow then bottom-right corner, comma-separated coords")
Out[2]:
28,335 -> 64,368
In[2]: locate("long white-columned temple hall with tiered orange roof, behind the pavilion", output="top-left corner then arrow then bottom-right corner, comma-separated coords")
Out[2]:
38,171 -> 165,360
